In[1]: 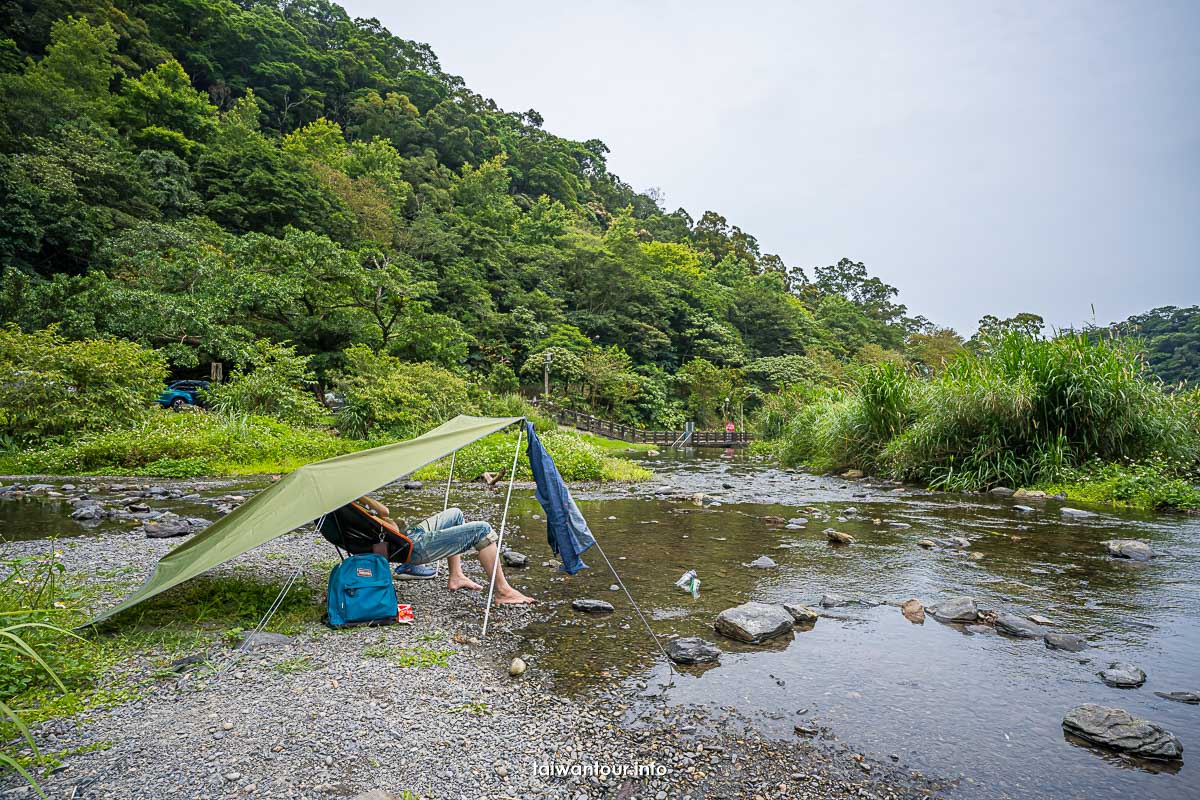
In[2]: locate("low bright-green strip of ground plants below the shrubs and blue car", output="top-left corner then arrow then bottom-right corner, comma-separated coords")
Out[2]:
8,411 -> 357,477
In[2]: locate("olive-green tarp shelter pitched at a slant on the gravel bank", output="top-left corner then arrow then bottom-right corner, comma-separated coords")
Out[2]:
90,416 -> 524,624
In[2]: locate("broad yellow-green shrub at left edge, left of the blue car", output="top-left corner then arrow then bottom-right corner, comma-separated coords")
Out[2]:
0,325 -> 167,441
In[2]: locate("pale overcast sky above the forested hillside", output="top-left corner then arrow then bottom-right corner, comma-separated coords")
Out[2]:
342,0 -> 1200,333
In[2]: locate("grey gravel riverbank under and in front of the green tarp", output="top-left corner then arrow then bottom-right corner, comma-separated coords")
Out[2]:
0,482 -> 937,800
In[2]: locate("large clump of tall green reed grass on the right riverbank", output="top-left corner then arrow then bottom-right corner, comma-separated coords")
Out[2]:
779,333 -> 1200,491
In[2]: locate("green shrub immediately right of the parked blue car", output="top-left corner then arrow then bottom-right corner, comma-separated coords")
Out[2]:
205,339 -> 325,426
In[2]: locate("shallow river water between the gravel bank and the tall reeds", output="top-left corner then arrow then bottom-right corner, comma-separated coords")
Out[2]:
512,457 -> 1200,799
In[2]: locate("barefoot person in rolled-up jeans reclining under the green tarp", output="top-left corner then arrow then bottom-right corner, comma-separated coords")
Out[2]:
349,495 -> 535,604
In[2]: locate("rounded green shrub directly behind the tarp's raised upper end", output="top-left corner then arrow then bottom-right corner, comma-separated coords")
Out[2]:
335,344 -> 475,439
